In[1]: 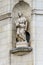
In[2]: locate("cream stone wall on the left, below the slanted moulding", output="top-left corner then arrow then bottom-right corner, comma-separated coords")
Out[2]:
0,18 -> 12,65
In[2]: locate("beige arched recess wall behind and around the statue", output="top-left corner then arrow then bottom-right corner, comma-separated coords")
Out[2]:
12,1 -> 31,47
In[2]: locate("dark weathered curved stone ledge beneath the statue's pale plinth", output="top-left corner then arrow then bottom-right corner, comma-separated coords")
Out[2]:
10,47 -> 32,56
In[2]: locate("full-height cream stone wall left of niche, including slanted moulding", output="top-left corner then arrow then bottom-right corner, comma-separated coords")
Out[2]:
0,0 -> 12,65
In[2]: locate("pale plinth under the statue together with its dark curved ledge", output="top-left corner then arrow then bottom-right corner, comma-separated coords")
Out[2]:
10,41 -> 32,56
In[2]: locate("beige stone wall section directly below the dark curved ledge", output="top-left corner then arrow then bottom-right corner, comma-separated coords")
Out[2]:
11,52 -> 33,65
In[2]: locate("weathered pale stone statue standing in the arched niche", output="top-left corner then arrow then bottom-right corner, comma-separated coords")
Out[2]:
15,12 -> 29,42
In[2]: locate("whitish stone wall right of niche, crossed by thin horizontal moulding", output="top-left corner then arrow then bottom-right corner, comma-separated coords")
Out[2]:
32,0 -> 43,65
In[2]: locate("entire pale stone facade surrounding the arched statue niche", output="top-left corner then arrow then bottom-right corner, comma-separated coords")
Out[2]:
0,0 -> 43,65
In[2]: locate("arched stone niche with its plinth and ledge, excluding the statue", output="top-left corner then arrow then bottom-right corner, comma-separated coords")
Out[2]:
10,0 -> 32,55
